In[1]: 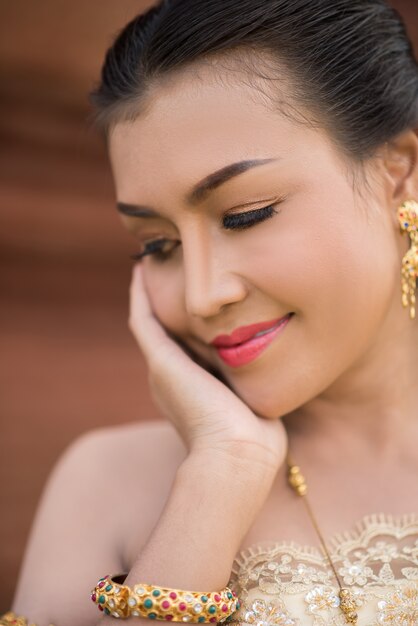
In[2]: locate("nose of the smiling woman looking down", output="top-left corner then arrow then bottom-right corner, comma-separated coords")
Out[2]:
182,231 -> 247,318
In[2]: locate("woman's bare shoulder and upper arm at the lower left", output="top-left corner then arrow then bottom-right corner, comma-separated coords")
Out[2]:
12,422 -> 187,626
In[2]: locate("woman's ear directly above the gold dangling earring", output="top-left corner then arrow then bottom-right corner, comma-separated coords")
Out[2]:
381,130 -> 418,206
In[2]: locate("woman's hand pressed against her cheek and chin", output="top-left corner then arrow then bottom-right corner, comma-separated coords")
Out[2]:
129,264 -> 287,472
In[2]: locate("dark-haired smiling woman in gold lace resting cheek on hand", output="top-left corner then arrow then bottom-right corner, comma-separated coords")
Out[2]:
4,0 -> 418,626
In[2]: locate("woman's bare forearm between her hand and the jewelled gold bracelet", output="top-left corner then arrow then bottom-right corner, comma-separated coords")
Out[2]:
117,442 -> 274,590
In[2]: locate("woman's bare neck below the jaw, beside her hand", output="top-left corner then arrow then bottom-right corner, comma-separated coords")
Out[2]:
282,310 -> 418,469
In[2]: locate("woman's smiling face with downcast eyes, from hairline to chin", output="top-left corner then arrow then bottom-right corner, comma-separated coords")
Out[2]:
109,66 -> 406,418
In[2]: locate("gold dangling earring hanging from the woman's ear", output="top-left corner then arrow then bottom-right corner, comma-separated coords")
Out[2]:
398,200 -> 418,320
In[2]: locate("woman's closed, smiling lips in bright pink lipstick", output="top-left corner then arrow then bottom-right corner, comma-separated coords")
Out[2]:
211,313 -> 293,367
